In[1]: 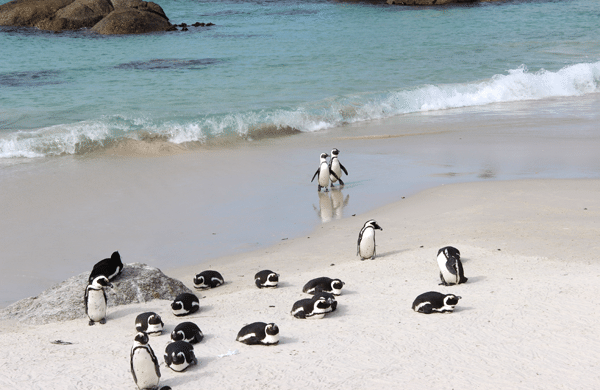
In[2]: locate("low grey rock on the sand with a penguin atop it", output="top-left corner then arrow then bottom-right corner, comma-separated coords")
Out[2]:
0,263 -> 192,325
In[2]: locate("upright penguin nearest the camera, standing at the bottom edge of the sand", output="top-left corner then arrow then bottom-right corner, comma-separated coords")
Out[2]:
129,332 -> 164,390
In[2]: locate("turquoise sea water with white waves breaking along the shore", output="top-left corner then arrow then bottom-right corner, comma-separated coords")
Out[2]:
0,0 -> 600,158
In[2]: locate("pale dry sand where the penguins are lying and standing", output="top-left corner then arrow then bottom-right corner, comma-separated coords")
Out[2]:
0,180 -> 600,389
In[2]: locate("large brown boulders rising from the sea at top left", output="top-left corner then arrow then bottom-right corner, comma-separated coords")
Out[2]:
0,0 -> 171,34
